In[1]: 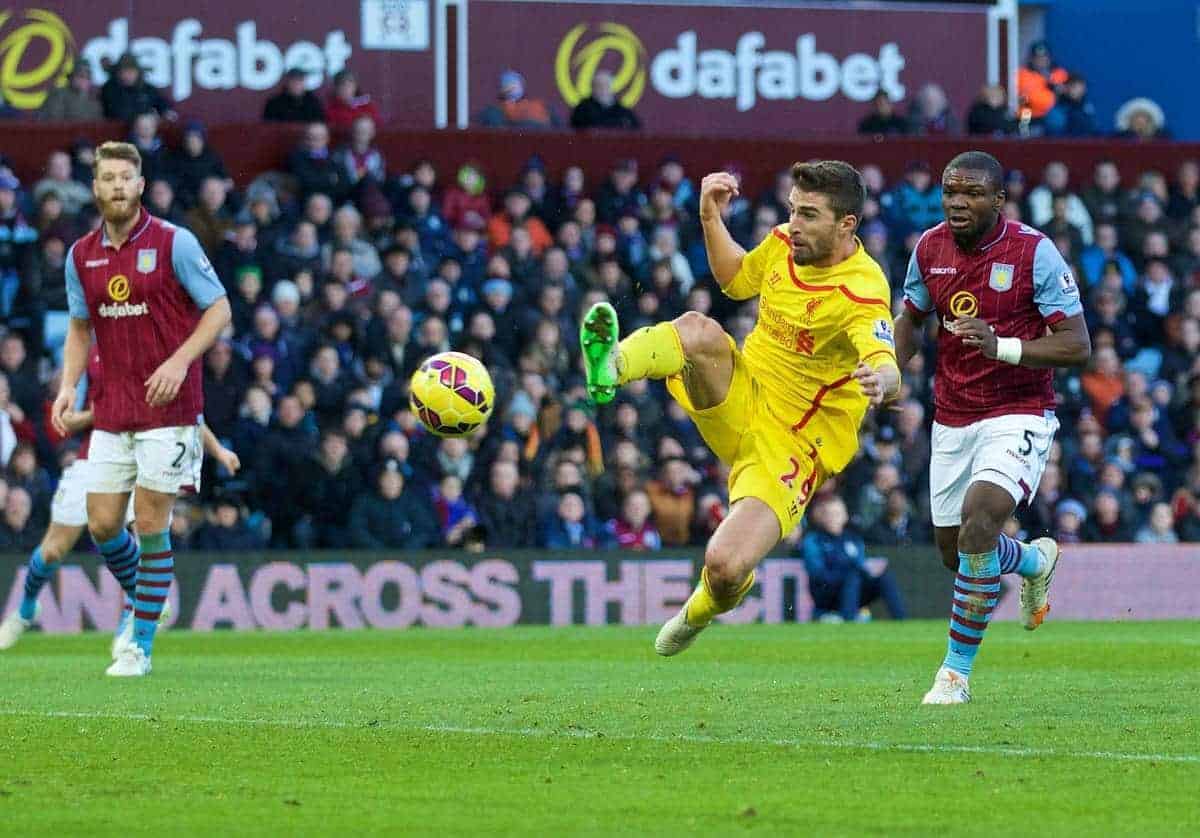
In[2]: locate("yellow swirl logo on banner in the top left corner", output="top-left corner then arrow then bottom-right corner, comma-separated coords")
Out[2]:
0,8 -> 76,110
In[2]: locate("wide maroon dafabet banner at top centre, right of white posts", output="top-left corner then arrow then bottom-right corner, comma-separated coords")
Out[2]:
469,0 -> 988,137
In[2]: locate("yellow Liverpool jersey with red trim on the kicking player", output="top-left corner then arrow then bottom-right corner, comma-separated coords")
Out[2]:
725,225 -> 895,473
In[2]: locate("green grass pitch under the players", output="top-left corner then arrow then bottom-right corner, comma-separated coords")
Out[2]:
0,621 -> 1200,838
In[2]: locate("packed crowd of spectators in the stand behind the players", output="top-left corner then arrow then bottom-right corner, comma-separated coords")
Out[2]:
0,60 -> 1200,551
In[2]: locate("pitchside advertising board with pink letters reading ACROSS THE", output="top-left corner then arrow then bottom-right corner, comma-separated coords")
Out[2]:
0,545 -> 1200,634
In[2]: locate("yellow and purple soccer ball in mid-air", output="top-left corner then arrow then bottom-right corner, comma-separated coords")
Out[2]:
408,352 -> 496,437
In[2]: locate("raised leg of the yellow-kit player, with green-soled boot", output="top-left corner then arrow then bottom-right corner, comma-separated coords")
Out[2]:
580,303 -> 733,409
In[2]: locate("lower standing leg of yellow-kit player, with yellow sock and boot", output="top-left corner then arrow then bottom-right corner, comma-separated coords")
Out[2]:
654,497 -> 781,656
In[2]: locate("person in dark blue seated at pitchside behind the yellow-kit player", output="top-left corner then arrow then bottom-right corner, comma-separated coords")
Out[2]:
800,495 -> 905,622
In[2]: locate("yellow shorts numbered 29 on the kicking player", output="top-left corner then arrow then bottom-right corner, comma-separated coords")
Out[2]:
666,337 -> 828,535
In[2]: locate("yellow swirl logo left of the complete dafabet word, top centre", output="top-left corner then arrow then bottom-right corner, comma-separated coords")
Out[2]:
554,23 -> 646,108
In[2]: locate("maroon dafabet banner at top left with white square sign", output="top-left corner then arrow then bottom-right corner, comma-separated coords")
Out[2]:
0,0 -> 437,127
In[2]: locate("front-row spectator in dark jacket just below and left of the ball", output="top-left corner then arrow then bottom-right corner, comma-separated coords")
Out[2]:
349,460 -> 440,550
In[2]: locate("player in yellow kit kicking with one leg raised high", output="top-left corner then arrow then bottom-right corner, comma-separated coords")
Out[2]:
580,161 -> 900,656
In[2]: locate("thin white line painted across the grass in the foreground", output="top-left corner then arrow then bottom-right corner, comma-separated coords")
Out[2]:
0,710 -> 1200,765
